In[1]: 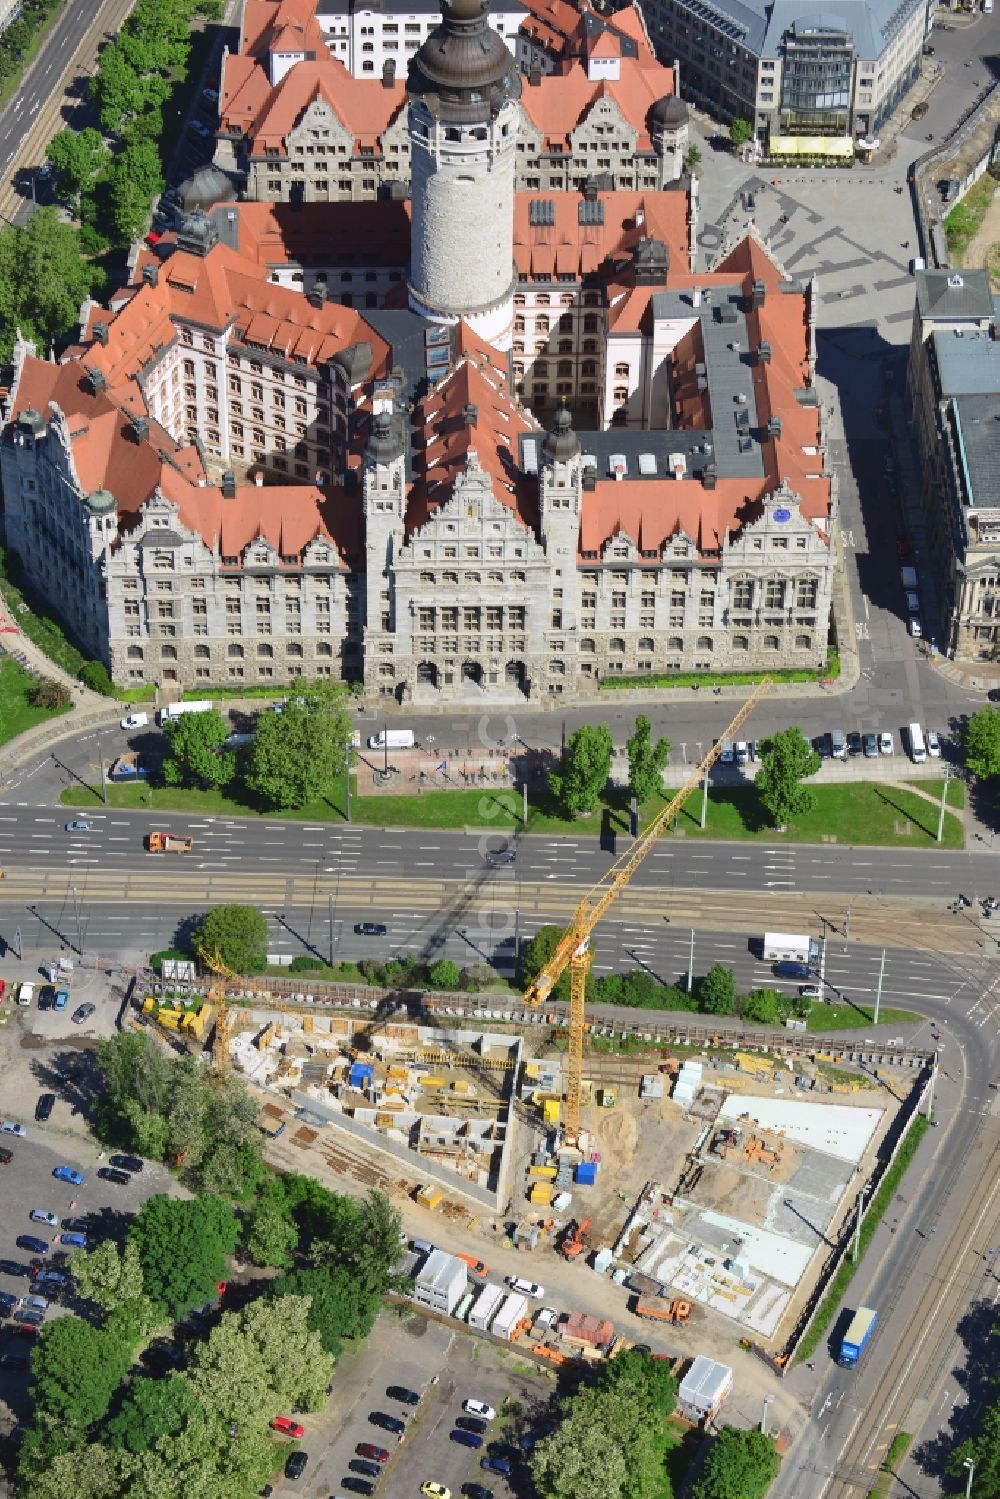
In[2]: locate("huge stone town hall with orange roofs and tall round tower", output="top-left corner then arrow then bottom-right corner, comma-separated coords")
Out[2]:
0,0 -> 837,702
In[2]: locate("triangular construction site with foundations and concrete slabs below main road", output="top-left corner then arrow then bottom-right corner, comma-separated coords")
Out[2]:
138,971 -> 919,1346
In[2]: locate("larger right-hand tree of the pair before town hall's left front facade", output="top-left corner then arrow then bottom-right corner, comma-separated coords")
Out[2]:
246,682 -> 351,808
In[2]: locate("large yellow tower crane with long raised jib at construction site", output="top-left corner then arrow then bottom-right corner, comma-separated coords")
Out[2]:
525,676 -> 772,1145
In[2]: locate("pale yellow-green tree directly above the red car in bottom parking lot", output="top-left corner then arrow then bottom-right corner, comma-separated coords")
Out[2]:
190,1297 -> 333,1421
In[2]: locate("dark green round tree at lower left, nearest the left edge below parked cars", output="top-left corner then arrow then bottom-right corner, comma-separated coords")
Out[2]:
31,1313 -> 133,1432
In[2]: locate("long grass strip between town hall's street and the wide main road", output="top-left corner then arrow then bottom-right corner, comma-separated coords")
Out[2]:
61,776 -> 964,848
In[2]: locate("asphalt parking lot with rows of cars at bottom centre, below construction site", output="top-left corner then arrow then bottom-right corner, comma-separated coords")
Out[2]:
293,1310 -> 555,1499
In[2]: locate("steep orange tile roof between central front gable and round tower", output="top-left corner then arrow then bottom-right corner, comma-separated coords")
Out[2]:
406,355 -> 540,532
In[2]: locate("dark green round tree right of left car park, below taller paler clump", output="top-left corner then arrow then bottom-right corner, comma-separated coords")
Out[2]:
127,1196 -> 240,1321
